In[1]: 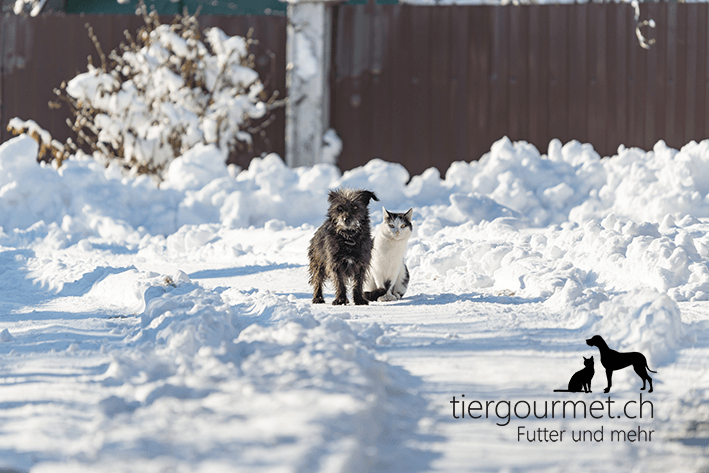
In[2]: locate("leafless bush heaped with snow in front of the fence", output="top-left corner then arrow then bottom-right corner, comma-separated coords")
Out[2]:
15,5 -> 281,179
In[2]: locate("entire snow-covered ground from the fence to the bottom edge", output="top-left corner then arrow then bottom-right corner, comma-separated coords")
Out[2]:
0,136 -> 709,473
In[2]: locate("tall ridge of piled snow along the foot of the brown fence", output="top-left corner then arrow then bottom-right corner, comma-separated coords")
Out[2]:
8,133 -> 709,234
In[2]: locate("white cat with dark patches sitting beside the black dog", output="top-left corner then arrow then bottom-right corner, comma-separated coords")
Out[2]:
364,209 -> 414,302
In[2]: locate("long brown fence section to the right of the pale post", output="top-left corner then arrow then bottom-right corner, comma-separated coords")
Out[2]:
331,2 -> 709,174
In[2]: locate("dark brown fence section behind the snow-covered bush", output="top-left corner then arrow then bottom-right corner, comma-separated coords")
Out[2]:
0,14 -> 286,166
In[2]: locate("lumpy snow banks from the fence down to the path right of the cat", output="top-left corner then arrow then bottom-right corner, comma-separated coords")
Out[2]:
0,131 -> 709,352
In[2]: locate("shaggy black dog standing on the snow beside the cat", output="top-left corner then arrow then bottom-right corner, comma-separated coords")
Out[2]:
308,189 -> 379,305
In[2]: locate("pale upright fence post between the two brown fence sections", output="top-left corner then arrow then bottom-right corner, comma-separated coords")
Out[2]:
286,0 -> 335,167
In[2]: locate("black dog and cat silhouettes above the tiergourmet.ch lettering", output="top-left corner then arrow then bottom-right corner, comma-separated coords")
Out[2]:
554,335 -> 657,393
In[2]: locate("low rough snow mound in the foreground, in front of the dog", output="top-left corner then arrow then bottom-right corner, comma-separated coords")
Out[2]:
74,270 -> 426,471
